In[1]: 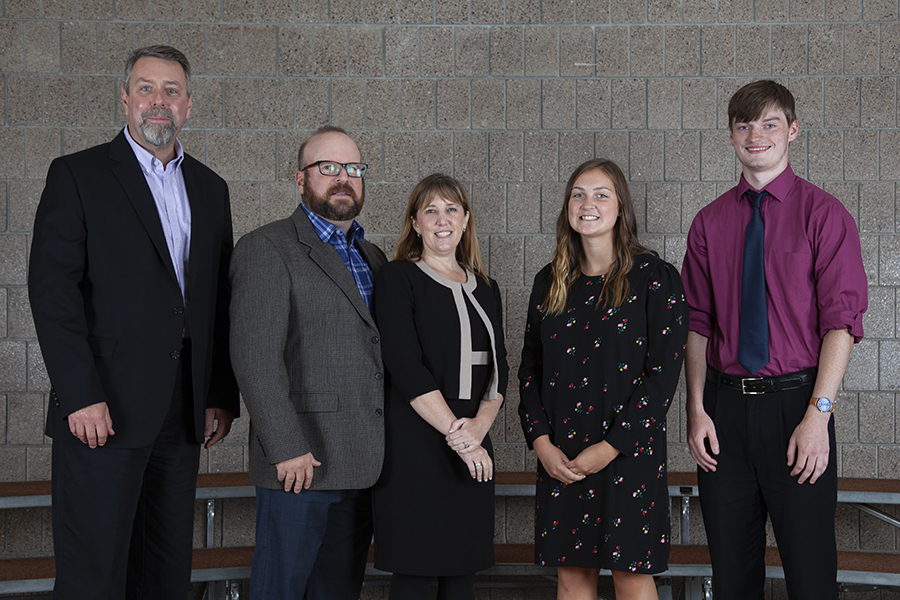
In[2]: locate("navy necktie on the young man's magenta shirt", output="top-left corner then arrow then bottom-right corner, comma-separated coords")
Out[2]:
738,190 -> 769,374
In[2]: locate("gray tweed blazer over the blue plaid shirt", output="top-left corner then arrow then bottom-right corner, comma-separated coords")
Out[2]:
230,207 -> 386,490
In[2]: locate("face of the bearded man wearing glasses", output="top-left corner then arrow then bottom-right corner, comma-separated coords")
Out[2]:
296,131 -> 366,232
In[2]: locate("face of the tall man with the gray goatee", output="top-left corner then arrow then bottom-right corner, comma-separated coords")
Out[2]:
122,56 -> 192,162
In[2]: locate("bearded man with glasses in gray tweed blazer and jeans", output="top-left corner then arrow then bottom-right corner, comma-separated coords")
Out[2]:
231,126 -> 386,600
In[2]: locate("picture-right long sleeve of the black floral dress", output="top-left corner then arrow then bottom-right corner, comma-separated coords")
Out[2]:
605,263 -> 688,456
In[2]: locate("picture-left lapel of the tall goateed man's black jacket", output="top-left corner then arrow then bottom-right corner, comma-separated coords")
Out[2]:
109,131 -> 178,283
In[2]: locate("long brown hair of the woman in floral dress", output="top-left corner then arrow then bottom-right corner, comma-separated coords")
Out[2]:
544,158 -> 656,315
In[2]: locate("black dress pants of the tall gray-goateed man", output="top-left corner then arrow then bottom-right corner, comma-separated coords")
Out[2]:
52,352 -> 200,600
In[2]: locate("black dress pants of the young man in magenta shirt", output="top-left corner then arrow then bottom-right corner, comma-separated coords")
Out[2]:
698,372 -> 838,600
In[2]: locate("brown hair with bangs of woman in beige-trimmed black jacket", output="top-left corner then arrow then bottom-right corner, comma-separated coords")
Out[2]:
394,173 -> 487,279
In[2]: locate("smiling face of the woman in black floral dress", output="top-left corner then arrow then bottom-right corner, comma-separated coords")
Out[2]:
568,169 -> 619,239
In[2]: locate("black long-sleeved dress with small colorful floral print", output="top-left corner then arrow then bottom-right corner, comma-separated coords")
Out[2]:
519,254 -> 688,574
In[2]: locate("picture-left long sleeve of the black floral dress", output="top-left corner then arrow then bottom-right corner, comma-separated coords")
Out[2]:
519,265 -> 553,448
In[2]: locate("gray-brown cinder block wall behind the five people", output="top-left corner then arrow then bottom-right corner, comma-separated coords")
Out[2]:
0,0 -> 900,572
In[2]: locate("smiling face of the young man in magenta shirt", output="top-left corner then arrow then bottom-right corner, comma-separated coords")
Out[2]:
731,105 -> 799,183
